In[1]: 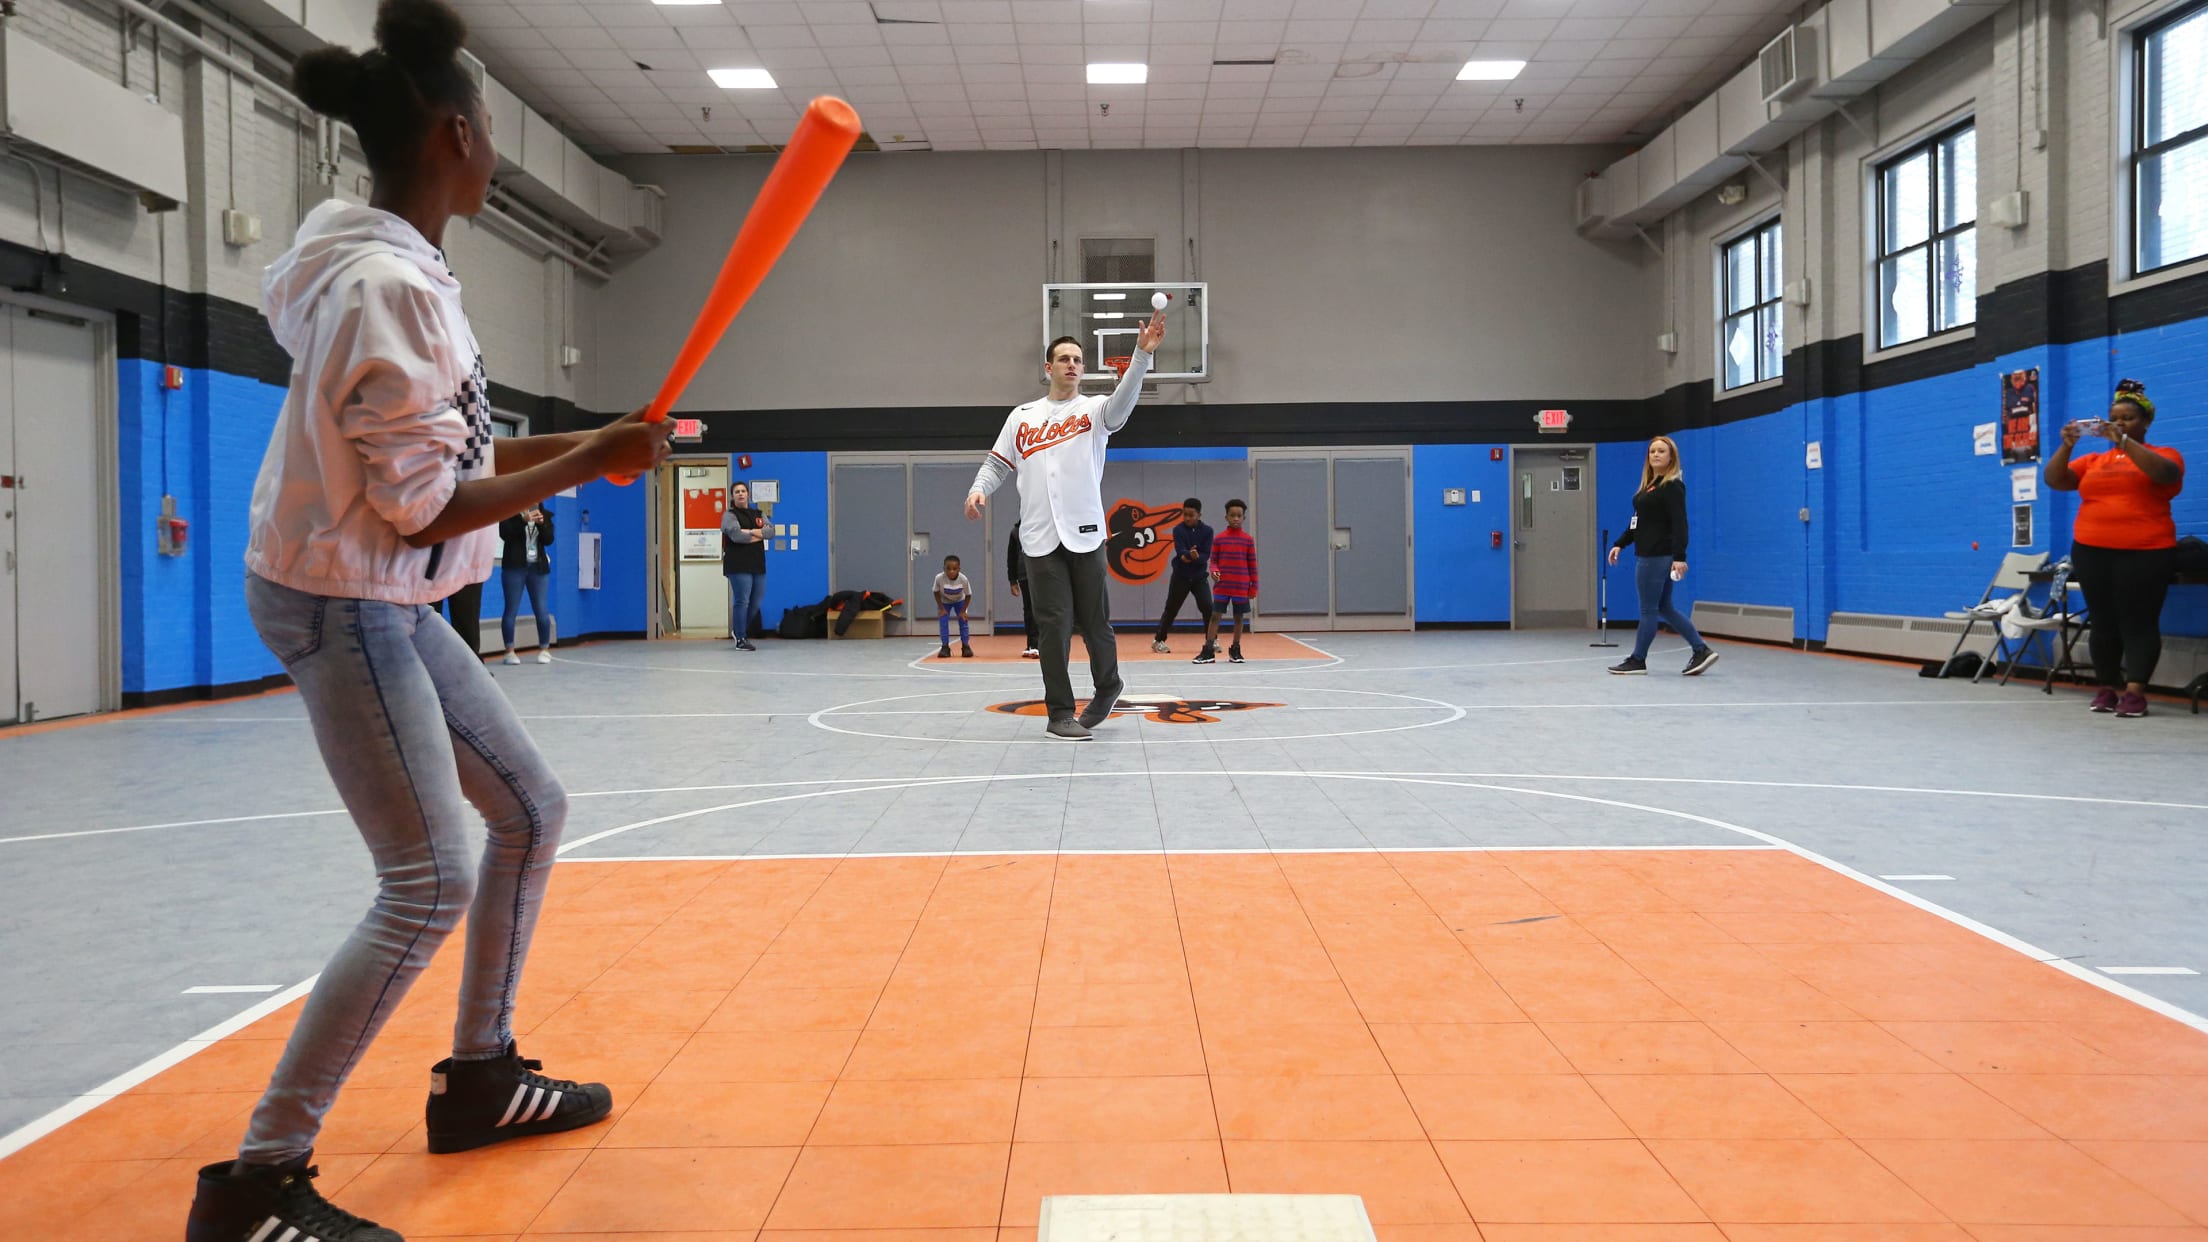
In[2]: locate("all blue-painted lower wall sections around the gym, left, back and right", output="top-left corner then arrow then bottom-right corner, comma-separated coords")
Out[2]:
117,307 -> 2208,696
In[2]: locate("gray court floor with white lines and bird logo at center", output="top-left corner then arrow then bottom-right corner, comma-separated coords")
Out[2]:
0,632 -> 2208,1134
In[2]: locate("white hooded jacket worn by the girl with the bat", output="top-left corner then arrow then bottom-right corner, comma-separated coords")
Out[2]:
245,199 -> 499,603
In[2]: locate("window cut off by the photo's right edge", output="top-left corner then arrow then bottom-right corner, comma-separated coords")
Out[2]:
2131,4 -> 2208,274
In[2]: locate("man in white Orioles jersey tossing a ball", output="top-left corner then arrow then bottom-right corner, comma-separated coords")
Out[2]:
967,312 -> 1166,743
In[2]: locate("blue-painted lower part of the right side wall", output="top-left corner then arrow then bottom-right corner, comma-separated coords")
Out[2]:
1678,318 -> 2208,639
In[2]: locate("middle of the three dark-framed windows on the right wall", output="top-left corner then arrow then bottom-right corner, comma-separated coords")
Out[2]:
1877,122 -> 1978,349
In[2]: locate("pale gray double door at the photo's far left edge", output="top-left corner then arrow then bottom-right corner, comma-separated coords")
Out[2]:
0,303 -> 109,723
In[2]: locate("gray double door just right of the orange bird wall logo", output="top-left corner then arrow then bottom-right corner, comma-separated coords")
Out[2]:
1250,449 -> 1413,630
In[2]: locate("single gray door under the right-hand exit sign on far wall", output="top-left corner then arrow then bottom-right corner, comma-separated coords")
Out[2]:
1510,446 -> 1601,630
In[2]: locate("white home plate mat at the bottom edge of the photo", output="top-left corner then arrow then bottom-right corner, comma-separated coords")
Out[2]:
1038,1196 -> 1376,1242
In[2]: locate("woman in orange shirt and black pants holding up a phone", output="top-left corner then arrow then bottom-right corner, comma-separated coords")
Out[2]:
2045,380 -> 2186,716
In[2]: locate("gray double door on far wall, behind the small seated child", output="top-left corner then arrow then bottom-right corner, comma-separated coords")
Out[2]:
828,453 -> 998,634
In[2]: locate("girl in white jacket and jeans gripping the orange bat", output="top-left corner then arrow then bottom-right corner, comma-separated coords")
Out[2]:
185,0 -> 673,1242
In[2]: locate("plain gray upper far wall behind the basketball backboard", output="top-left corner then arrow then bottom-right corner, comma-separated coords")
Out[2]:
598,146 -> 1660,409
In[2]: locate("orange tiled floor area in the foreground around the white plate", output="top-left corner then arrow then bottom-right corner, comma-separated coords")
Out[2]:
0,851 -> 2208,1242
